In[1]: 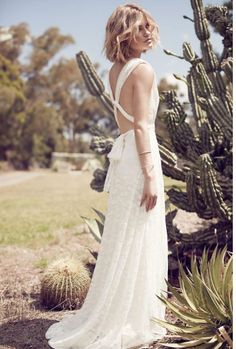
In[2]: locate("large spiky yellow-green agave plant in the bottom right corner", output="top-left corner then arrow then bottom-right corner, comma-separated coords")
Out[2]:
152,245 -> 233,349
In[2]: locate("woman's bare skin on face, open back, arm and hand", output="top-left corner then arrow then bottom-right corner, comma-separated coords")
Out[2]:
109,17 -> 157,211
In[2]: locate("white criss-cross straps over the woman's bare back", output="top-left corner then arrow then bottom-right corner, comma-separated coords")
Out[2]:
107,58 -> 147,124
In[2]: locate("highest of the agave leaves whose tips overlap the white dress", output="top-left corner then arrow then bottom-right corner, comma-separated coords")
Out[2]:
156,295 -> 208,325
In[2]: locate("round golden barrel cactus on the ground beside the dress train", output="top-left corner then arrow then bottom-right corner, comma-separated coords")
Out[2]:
40,257 -> 91,310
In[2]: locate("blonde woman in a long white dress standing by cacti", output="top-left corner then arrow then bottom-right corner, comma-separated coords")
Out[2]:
46,4 -> 168,349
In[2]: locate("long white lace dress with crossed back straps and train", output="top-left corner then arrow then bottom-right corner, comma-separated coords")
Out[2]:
45,58 -> 168,349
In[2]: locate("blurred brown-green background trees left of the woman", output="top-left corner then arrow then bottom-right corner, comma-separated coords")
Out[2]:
0,23 -> 103,168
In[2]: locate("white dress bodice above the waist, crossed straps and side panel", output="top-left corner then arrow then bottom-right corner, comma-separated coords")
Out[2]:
107,58 -> 159,125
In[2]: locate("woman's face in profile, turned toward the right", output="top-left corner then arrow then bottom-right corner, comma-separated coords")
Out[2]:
130,16 -> 152,52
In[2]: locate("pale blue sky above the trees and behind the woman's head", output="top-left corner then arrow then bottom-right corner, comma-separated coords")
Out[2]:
0,0 -> 223,89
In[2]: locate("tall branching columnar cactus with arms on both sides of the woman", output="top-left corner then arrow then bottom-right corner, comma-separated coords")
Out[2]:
77,0 -> 233,270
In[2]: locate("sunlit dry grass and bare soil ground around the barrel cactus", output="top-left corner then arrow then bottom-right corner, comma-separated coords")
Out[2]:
0,173 -> 190,349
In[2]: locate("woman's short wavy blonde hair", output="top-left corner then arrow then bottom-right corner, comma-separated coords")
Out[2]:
102,4 -> 160,62
